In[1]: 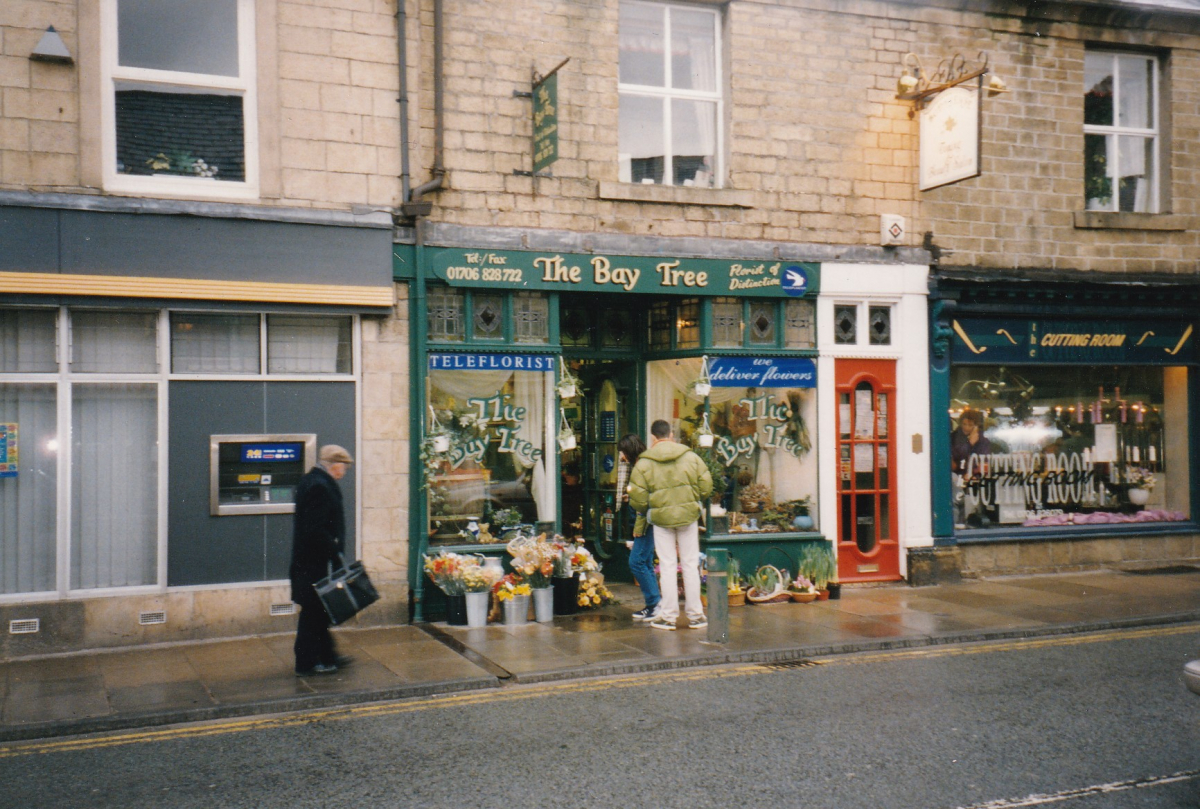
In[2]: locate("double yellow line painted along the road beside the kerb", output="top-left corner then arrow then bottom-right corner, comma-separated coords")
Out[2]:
0,624 -> 1200,759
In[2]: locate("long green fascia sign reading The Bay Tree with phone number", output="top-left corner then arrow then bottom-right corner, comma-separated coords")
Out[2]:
427,247 -> 821,298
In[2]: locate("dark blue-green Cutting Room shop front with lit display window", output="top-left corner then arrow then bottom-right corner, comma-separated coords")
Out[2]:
931,277 -> 1198,573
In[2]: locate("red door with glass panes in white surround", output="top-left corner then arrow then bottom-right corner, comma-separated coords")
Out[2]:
834,359 -> 900,582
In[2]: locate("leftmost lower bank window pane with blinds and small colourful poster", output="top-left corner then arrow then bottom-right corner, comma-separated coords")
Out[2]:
0,384 -> 59,594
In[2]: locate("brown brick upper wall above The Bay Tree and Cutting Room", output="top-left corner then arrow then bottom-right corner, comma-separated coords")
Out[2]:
414,0 -> 1200,272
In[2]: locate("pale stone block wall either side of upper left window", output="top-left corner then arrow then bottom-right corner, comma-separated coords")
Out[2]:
0,0 -> 405,209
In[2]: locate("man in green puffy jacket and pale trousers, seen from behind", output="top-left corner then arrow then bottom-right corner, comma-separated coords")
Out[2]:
629,419 -> 713,630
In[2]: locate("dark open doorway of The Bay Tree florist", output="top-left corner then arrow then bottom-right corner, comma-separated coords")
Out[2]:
562,359 -> 643,581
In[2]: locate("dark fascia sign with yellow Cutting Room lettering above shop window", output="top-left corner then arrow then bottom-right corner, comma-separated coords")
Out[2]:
950,317 -> 1196,365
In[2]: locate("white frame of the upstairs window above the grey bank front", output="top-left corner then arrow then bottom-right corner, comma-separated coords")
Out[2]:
100,0 -> 259,199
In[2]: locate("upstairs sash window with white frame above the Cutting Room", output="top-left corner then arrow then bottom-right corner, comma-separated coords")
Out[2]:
1084,50 -> 1159,212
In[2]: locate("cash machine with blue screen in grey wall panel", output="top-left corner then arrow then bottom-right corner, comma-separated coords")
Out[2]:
209,433 -> 317,516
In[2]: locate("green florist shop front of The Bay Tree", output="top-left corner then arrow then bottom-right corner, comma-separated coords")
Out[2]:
396,246 -> 828,621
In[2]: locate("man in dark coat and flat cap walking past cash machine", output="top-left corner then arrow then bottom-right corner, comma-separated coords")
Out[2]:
289,444 -> 354,677
